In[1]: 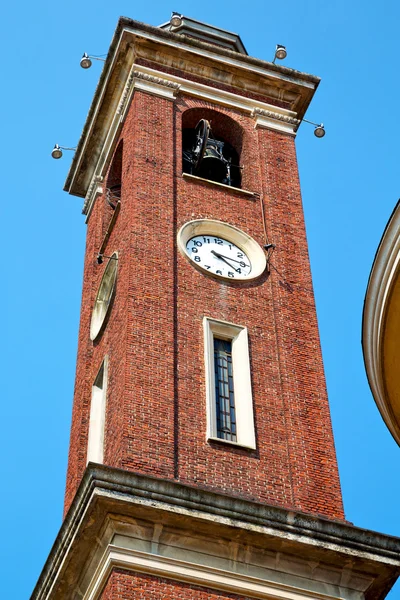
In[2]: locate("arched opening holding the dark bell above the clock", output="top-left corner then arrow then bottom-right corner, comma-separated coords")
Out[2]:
182,108 -> 243,188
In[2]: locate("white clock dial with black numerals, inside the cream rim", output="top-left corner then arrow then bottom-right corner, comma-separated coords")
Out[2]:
186,233 -> 252,279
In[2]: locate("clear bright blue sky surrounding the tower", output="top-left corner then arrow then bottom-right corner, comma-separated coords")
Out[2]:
0,0 -> 400,600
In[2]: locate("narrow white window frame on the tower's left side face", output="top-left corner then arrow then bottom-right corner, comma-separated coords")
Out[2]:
86,356 -> 108,464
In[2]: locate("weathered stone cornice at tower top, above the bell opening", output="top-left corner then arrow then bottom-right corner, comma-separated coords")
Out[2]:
64,19 -> 319,203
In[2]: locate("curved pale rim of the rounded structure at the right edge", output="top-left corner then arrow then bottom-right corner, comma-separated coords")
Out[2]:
363,204 -> 400,445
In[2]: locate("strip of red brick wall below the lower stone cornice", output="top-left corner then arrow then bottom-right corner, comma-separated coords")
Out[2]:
100,569 -> 253,600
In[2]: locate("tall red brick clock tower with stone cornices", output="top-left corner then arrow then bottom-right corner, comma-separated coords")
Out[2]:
33,15 -> 400,600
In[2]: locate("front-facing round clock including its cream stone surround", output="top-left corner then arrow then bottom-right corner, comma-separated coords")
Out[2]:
178,219 -> 266,281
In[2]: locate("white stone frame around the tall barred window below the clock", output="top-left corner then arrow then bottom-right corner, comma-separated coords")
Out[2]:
203,317 -> 256,450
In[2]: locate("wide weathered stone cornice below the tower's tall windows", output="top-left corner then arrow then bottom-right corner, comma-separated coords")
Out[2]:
32,463 -> 400,600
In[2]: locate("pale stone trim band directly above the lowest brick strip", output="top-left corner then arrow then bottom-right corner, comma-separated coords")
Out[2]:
82,544 -> 344,600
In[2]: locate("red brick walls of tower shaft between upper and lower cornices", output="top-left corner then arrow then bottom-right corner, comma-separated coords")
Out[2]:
65,83 -> 344,520
